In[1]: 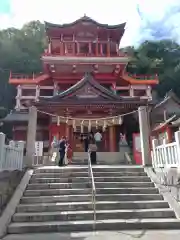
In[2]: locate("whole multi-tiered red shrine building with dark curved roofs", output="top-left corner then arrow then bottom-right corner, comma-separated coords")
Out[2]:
5,16 -> 158,152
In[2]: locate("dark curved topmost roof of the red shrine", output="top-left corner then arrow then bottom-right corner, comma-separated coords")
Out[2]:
45,15 -> 126,30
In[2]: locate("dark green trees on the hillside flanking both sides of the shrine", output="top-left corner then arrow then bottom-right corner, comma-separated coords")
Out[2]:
0,21 -> 180,113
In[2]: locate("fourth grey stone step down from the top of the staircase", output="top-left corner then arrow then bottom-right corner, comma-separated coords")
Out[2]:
27,182 -> 154,190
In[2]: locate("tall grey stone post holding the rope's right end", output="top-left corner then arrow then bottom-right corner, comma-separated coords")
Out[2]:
138,106 -> 152,166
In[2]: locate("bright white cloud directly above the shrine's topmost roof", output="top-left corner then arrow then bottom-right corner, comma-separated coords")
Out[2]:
0,0 -> 139,45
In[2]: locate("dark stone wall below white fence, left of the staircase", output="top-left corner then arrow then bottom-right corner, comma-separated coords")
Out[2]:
0,170 -> 25,215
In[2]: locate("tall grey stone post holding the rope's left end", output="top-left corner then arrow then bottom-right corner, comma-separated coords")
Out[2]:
25,106 -> 37,167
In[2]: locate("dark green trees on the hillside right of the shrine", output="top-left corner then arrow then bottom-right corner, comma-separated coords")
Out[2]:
127,40 -> 180,97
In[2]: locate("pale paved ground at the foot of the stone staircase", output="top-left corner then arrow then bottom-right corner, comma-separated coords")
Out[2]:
3,230 -> 180,240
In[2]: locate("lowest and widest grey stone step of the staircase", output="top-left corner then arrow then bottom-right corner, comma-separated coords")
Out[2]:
8,218 -> 180,234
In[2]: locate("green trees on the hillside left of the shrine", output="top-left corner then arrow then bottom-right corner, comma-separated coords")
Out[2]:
0,21 -> 46,109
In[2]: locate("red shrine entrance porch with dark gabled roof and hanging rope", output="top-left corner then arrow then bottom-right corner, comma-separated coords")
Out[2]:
35,74 -> 147,157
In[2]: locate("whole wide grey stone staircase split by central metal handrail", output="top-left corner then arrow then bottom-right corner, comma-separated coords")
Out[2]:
8,166 -> 180,234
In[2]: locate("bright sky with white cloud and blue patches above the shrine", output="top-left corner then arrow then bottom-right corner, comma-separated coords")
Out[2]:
0,0 -> 180,46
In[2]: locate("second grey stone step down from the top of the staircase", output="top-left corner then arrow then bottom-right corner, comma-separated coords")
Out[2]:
32,172 -> 147,179
